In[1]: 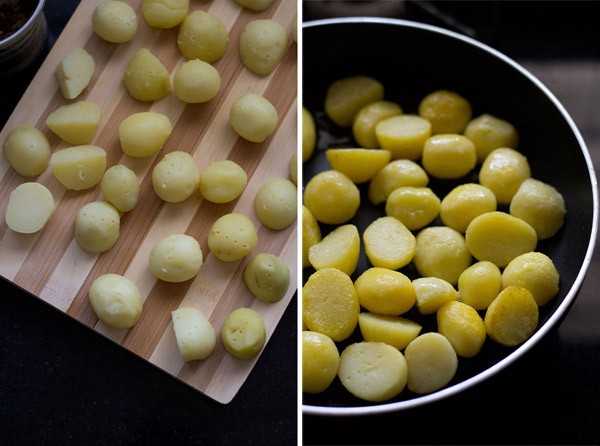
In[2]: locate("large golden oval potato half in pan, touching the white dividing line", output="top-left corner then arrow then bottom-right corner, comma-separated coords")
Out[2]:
302,268 -> 360,342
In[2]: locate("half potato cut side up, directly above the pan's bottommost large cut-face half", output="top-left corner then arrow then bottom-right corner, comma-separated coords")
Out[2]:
358,311 -> 422,350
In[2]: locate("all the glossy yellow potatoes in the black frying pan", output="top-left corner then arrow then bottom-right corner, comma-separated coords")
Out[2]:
302,75 -> 566,402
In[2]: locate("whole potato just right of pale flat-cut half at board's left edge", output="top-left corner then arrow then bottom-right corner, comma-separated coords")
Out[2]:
75,201 -> 121,254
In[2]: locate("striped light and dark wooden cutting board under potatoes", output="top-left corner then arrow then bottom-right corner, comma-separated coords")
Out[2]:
0,0 -> 297,403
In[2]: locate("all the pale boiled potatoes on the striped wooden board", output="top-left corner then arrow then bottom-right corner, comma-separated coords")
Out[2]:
4,0 -> 297,361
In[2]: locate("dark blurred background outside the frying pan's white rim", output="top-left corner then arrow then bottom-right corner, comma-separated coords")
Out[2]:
302,1 -> 600,445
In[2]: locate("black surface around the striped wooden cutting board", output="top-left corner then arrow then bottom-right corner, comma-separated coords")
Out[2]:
0,0 -> 298,446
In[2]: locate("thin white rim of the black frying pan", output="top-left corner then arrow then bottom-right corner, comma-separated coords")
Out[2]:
302,17 -> 598,416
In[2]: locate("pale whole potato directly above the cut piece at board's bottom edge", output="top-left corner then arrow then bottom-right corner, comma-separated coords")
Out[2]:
149,234 -> 204,282
